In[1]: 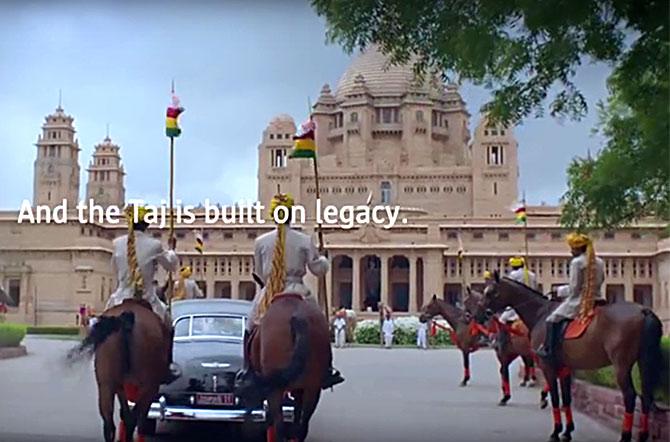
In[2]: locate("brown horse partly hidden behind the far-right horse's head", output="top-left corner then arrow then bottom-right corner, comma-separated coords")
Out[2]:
463,288 -> 548,408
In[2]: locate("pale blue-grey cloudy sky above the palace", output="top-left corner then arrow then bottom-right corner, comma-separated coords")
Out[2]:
0,0 -> 609,209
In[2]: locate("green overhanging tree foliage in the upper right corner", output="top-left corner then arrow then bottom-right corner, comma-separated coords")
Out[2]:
312,0 -> 670,228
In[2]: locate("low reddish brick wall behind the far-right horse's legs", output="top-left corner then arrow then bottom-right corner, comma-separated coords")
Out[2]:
572,380 -> 670,441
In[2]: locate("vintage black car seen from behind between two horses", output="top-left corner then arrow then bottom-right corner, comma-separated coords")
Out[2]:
145,299 -> 293,434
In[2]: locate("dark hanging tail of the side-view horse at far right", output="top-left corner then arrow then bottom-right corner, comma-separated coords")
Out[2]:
639,309 -> 663,403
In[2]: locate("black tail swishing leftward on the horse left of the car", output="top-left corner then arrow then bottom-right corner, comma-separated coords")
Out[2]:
67,312 -> 135,369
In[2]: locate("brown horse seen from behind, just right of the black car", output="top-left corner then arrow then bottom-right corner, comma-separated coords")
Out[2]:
236,294 -> 332,442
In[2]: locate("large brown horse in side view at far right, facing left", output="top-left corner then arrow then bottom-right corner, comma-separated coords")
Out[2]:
479,272 -> 662,442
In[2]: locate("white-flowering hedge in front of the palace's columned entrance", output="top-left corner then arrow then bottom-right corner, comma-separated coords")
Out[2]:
354,316 -> 451,346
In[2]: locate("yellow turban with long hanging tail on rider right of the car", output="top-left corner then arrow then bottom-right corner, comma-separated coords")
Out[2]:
258,193 -> 293,319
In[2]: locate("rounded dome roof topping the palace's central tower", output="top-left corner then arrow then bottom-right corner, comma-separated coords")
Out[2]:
336,46 -> 442,98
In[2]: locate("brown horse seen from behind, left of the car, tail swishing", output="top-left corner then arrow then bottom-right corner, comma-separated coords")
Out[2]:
68,299 -> 170,442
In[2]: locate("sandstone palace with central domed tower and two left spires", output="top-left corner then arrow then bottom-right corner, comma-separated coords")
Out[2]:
0,48 -> 670,333
